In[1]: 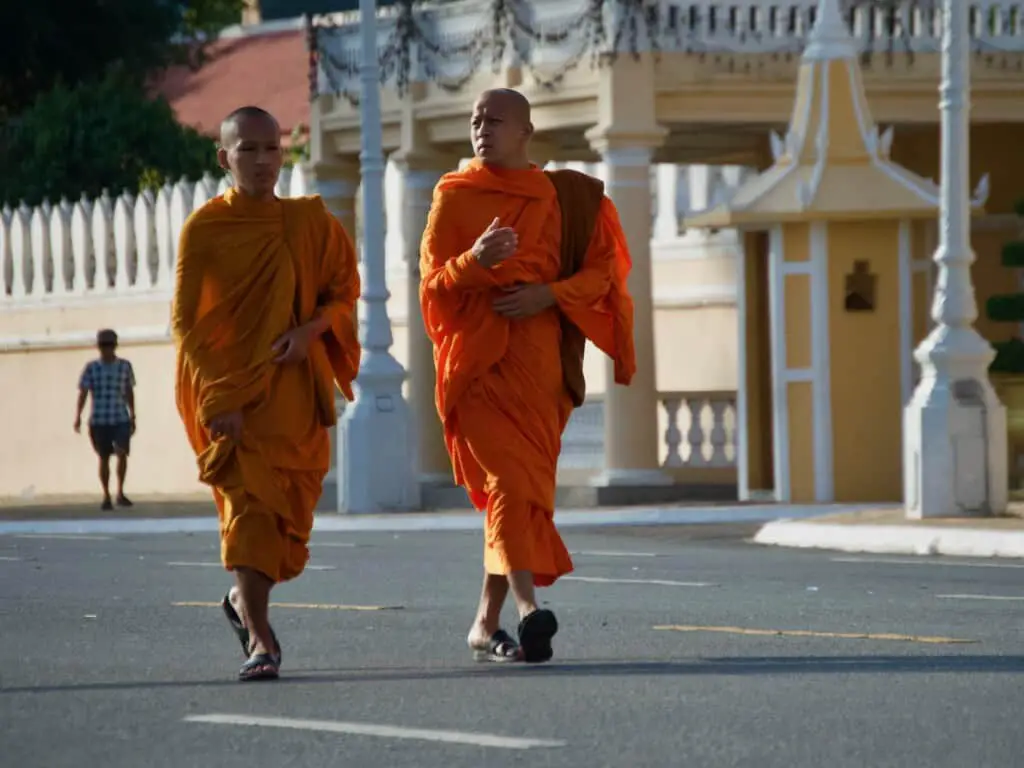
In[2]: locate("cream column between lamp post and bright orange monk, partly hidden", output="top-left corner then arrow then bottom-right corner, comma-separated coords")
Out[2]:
391,152 -> 456,484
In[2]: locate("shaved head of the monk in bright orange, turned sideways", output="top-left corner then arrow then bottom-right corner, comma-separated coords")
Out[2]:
471,88 -> 534,168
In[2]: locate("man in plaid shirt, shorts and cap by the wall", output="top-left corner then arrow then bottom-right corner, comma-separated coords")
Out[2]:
75,329 -> 135,509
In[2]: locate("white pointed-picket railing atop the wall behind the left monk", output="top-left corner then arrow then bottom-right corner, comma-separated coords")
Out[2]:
0,166 -> 311,307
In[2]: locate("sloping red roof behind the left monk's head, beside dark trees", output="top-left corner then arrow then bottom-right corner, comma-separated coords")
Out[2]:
155,31 -> 309,144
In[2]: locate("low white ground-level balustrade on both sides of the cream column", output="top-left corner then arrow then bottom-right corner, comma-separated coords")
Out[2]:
558,391 -> 736,470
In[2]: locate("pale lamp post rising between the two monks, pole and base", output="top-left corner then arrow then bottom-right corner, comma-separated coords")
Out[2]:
338,0 -> 420,512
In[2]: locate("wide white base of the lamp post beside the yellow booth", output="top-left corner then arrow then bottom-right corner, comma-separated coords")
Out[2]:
903,326 -> 1010,519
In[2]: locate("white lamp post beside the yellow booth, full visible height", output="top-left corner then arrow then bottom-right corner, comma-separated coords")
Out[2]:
903,0 -> 1009,518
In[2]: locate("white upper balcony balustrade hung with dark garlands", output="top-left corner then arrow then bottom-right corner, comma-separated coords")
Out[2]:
313,0 -> 1024,96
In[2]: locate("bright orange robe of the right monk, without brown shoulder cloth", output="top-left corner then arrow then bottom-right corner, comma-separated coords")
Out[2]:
420,160 -> 636,587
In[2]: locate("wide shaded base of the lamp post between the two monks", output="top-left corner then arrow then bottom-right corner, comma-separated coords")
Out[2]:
338,351 -> 421,514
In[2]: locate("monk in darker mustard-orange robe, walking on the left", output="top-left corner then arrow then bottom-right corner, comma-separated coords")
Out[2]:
172,106 -> 360,680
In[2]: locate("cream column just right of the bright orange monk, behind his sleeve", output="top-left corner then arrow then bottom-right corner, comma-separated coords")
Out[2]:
593,136 -> 672,485
